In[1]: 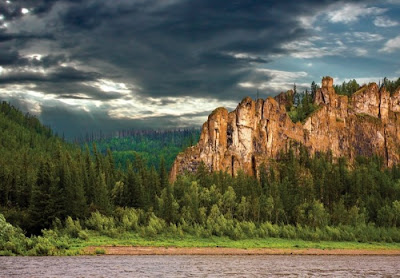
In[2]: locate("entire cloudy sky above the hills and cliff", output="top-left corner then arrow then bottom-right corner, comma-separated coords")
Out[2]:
0,0 -> 400,138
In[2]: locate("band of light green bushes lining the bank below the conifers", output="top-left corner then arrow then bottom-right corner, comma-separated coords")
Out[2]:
0,206 -> 400,256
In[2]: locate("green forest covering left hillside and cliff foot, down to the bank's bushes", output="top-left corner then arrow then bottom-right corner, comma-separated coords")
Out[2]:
0,95 -> 400,255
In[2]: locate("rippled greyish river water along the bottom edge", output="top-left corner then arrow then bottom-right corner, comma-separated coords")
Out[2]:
0,255 -> 400,278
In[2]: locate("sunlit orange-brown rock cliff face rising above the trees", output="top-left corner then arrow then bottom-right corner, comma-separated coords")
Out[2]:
170,77 -> 400,181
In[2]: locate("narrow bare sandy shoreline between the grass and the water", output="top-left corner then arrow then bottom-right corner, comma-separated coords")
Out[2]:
83,245 -> 400,256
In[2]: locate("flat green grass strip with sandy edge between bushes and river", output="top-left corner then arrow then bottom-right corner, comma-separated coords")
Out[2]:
63,233 -> 400,255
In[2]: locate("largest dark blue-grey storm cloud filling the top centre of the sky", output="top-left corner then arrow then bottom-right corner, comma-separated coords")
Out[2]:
47,1 -> 350,99
